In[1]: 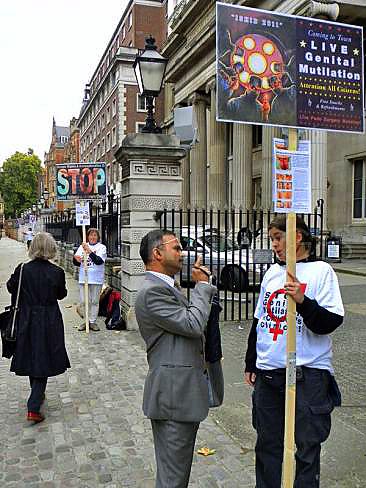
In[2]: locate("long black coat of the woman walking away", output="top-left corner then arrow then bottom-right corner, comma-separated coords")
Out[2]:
6,259 -> 70,377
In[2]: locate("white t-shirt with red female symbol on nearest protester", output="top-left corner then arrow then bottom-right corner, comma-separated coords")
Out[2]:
254,261 -> 344,373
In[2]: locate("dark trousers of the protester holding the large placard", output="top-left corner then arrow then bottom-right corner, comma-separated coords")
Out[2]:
253,367 -> 333,488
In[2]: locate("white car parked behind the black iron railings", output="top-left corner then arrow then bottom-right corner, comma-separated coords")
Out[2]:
180,226 -> 270,293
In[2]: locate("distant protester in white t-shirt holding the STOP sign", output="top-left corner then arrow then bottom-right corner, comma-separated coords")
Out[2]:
74,227 -> 107,331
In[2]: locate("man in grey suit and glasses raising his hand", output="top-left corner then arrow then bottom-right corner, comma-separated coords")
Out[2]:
135,230 -> 216,488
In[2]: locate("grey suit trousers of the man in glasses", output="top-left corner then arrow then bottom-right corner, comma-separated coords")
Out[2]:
151,420 -> 199,488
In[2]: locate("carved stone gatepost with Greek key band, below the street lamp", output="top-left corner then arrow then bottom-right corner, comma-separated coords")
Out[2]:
115,134 -> 185,330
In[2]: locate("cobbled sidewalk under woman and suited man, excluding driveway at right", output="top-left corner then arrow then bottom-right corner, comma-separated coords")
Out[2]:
0,238 -> 255,488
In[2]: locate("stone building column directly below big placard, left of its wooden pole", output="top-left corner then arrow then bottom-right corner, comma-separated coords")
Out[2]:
233,123 -> 253,209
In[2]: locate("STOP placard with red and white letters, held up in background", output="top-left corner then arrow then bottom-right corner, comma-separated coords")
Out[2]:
56,162 -> 107,201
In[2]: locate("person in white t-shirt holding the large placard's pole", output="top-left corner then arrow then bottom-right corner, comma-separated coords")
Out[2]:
245,214 -> 344,488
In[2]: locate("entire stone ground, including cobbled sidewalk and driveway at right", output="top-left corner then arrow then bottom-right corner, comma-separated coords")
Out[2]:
0,238 -> 366,488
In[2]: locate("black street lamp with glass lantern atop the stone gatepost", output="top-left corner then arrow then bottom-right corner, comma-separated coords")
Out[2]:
133,35 -> 168,134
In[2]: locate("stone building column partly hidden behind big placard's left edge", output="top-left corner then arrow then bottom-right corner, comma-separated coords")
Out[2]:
207,83 -> 227,210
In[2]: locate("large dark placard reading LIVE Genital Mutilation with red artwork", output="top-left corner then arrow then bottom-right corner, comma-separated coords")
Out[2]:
216,3 -> 364,133
